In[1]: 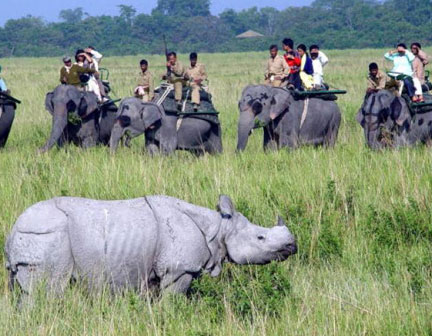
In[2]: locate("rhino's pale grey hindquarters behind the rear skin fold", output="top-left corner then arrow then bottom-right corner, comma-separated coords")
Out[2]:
6,203 -> 74,295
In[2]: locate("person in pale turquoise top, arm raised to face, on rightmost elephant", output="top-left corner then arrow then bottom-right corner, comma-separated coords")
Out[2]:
384,43 -> 424,103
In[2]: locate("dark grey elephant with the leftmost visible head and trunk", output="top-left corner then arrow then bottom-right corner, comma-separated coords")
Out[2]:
41,84 -> 118,152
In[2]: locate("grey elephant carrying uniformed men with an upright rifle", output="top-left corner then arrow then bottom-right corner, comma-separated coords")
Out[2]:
110,97 -> 222,155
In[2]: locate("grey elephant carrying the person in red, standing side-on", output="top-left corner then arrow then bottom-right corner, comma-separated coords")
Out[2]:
237,85 -> 341,151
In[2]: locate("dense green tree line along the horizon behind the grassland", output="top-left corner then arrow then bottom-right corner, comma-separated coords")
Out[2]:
0,0 -> 432,57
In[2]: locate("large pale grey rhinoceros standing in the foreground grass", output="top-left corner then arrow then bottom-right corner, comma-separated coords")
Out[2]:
6,195 -> 297,294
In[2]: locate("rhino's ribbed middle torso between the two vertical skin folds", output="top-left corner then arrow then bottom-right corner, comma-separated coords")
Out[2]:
56,198 -> 159,288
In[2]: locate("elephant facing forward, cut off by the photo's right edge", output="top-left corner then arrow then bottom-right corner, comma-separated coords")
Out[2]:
356,90 -> 432,149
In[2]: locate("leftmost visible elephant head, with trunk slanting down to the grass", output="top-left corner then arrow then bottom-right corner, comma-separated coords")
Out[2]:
41,85 -> 98,152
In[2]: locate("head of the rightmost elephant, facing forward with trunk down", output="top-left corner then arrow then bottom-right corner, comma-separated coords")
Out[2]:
356,90 -> 411,149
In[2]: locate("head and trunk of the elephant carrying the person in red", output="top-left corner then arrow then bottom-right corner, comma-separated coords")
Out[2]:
237,85 -> 293,151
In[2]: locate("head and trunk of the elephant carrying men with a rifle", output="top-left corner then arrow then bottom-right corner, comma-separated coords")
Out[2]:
110,97 -> 164,152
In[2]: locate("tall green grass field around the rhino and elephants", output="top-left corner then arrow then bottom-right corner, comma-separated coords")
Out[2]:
0,50 -> 432,336
